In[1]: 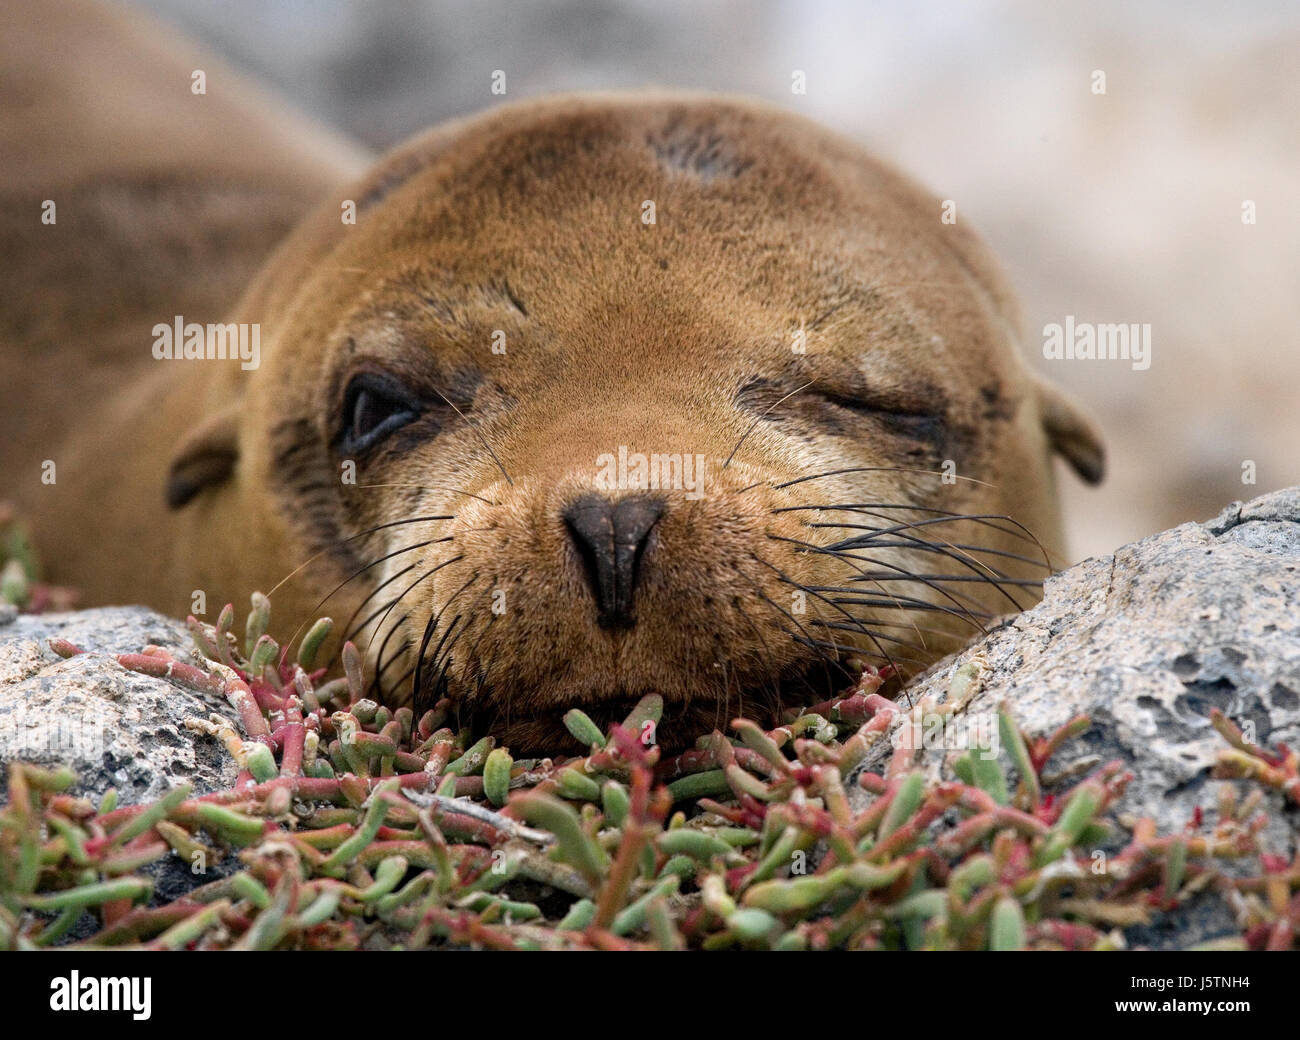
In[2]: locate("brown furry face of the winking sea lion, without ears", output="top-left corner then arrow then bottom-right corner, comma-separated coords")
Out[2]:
202,99 -> 1087,749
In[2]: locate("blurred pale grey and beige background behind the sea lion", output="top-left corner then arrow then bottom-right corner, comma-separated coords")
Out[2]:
138,0 -> 1300,558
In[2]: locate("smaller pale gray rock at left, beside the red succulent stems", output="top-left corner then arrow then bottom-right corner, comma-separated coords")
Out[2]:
0,607 -> 237,805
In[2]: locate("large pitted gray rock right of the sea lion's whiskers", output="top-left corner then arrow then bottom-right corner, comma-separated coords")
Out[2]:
852,488 -> 1300,946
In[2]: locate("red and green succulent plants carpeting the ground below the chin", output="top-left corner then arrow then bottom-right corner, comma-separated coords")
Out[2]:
0,595 -> 1300,949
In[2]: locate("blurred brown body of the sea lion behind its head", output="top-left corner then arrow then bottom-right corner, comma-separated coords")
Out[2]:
0,0 -> 369,616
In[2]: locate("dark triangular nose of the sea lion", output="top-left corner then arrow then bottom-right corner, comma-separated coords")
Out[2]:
560,494 -> 666,628
